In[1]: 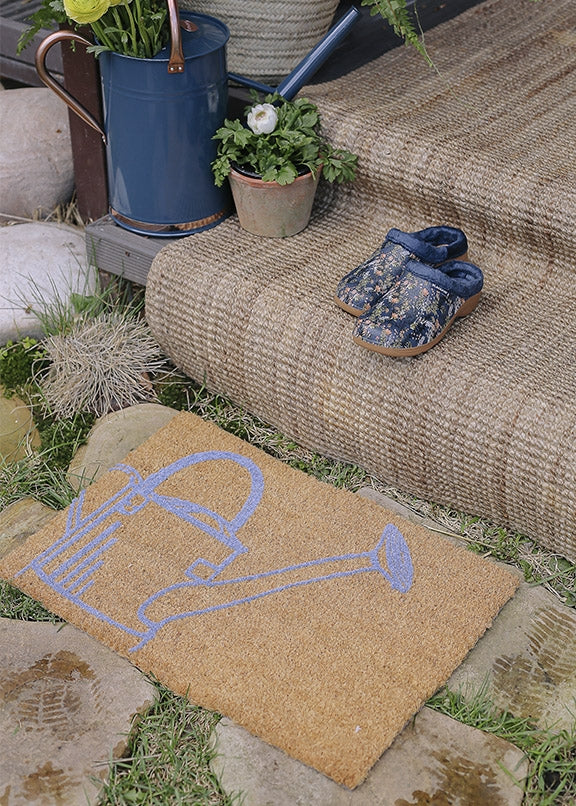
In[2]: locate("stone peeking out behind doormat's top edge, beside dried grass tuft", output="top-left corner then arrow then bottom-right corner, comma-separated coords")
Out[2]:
67,403 -> 178,489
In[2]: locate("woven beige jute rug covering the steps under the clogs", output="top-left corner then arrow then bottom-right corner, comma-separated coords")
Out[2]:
146,0 -> 576,561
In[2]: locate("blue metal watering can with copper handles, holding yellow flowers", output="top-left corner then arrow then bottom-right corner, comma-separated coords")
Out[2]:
36,0 -> 360,237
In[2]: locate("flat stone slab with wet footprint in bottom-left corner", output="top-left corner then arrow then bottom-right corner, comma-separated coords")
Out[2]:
0,619 -> 154,806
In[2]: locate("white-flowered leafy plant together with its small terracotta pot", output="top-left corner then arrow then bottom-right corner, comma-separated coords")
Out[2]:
212,92 -> 358,237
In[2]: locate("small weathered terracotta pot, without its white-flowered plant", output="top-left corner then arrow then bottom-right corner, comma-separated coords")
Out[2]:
228,169 -> 320,238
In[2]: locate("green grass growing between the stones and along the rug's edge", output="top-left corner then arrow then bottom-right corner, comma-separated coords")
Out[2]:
0,258 -> 576,806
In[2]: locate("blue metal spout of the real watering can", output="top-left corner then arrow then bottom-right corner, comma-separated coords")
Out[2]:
228,6 -> 360,101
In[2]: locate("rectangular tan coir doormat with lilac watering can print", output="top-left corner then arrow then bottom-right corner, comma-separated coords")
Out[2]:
0,413 -> 517,788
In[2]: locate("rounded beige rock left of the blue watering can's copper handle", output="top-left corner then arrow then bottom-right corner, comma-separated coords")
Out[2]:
0,87 -> 74,218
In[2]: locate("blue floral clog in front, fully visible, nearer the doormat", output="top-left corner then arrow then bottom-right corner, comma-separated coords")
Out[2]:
354,260 -> 484,357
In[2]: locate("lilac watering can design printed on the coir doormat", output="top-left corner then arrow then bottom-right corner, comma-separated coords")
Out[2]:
17,451 -> 414,652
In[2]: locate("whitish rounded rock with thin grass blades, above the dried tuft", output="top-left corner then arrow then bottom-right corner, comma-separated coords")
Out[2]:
0,222 -> 96,345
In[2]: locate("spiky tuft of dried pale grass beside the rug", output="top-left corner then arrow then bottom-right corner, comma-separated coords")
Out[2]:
39,311 -> 165,417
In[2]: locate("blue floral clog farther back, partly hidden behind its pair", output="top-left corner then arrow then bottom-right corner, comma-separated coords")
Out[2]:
334,227 -> 468,316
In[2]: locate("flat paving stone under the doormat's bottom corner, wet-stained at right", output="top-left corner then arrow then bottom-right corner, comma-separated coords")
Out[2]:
212,708 -> 527,806
